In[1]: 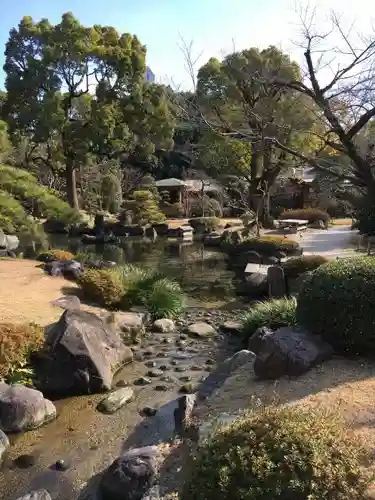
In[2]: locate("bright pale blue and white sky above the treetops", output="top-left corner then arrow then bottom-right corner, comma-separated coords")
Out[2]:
0,0 -> 372,88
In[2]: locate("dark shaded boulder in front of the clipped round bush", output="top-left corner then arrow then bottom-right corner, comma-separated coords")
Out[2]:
253,327 -> 333,380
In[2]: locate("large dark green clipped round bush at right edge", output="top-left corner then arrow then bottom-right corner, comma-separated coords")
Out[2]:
296,257 -> 375,354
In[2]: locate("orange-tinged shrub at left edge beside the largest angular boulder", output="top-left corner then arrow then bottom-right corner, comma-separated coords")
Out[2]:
0,323 -> 44,382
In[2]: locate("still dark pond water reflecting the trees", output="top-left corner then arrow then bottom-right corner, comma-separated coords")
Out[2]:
36,235 -> 235,301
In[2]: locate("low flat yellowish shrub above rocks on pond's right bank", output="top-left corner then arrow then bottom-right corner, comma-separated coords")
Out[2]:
228,236 -> 300,256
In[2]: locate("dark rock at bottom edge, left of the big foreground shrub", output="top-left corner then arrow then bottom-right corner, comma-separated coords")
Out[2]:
100,446 -> 159,500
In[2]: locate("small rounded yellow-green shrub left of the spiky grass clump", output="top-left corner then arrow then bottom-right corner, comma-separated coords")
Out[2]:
78,269 -> 124,307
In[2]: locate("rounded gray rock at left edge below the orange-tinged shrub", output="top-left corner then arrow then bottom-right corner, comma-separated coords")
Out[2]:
0,384 -> 56,432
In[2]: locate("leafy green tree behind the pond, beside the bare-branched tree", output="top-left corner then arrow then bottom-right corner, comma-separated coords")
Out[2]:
188,47 -> 318,219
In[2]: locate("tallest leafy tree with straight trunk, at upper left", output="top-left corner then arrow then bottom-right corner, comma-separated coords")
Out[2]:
4,13 -> 173,208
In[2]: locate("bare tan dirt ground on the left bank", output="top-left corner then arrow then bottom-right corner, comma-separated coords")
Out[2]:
0,259 -> 98,326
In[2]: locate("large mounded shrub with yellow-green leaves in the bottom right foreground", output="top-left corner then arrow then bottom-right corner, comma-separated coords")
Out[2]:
181,407 -> 373,500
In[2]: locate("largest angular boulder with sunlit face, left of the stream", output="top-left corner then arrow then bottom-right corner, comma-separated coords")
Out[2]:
36,310 -> 133,395
